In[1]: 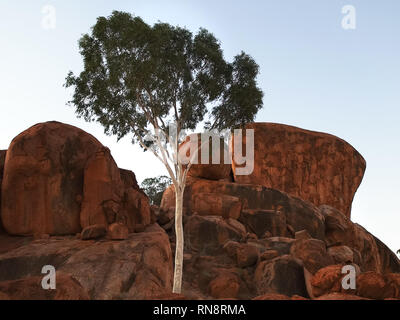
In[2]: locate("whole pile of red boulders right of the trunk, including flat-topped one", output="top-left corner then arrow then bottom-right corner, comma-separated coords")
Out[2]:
158,123 -> 400,300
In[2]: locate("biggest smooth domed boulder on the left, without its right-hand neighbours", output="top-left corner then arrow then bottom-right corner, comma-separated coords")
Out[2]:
1,122 -> 102,235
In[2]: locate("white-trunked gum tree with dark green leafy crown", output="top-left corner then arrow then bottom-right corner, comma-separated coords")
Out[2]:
65,11 -> 263,293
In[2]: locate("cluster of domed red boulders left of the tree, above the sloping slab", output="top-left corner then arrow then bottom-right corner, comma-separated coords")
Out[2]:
1,122 -> 150,235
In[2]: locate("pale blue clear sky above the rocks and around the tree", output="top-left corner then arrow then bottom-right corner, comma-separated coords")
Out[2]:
0,0 -> 400,250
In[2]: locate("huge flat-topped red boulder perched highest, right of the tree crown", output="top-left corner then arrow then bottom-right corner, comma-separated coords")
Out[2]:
231,123 -> 366,217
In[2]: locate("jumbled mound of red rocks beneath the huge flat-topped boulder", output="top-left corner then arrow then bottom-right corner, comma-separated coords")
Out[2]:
160,174 -> 400,299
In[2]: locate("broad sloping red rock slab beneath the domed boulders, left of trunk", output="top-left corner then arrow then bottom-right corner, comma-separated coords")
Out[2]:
0,225 -> 173,299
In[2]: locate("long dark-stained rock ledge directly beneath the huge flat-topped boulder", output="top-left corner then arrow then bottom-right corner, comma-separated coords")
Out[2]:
160,179 -> 325,240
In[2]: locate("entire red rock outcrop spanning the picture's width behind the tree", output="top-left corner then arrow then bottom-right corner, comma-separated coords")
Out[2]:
0,122 -> 400,300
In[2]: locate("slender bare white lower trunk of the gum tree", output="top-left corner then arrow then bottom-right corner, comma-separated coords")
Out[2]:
172,185 -> 184,293
